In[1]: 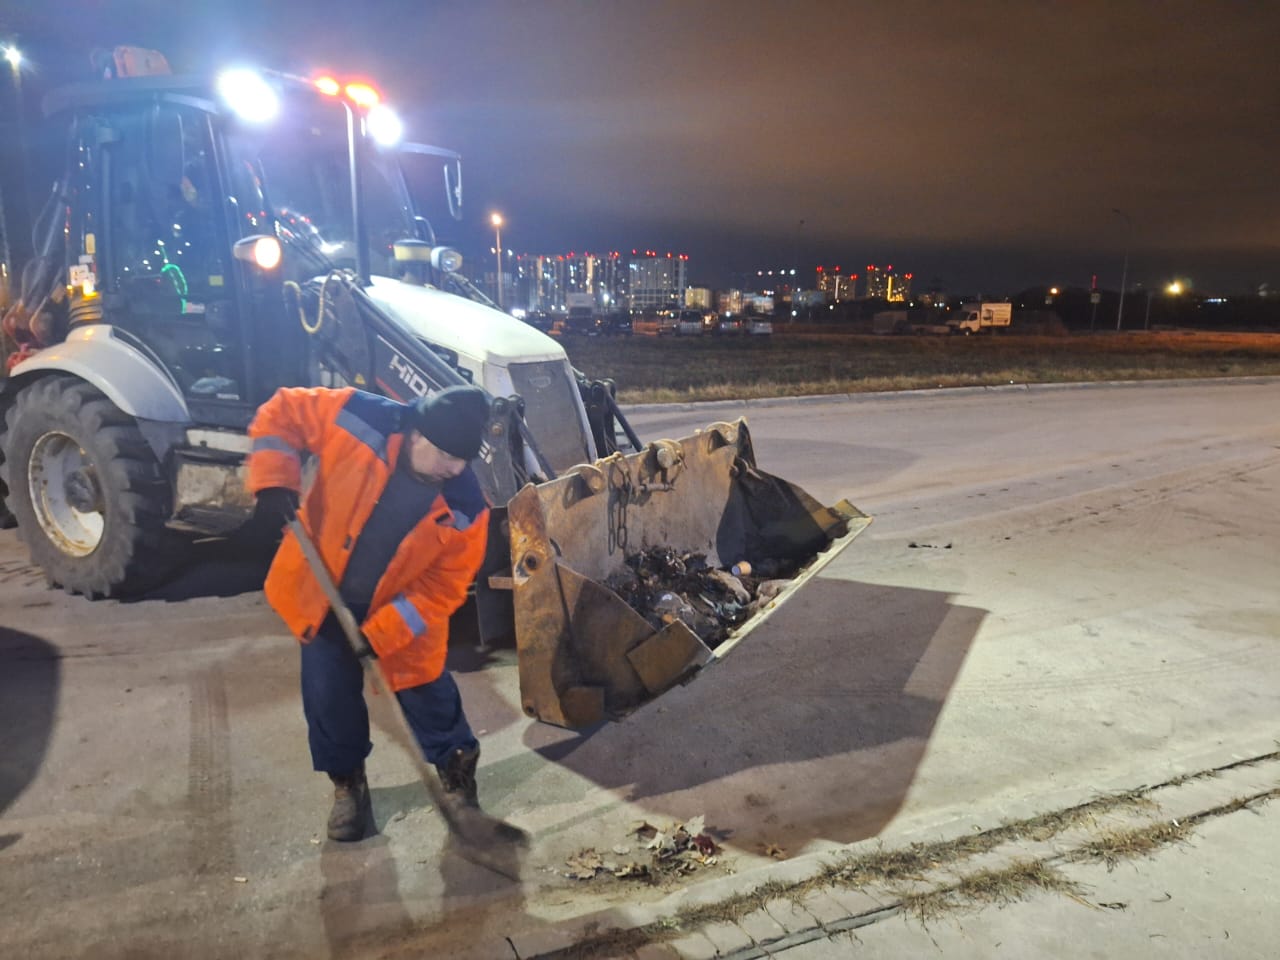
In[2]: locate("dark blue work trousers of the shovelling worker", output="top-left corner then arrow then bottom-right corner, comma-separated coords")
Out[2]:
302,613 -> 477,774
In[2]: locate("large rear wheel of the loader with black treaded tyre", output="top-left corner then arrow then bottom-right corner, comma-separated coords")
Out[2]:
0,376 -> 170,598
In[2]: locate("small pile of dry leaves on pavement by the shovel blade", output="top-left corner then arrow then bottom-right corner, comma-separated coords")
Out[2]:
564,817 -> 719,883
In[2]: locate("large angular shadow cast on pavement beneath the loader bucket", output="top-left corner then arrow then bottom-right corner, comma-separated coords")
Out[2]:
525,579 -> 984,847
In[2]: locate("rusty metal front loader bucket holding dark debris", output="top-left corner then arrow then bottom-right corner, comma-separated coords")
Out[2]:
502,420 -> 870,727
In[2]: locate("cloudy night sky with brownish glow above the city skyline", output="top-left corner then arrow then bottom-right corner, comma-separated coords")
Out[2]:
0,0 -> 1280,293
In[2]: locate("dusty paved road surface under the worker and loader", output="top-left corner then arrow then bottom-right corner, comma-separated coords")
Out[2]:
0,380 -> 1280,957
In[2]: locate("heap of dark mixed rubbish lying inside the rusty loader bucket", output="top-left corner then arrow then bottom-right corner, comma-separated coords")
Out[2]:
605,547 -> 796,649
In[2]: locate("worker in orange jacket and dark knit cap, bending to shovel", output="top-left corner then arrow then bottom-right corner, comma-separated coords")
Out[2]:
248,387 -> 489,840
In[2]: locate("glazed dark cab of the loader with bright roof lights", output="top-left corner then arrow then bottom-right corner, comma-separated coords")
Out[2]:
20,64 -> 468,426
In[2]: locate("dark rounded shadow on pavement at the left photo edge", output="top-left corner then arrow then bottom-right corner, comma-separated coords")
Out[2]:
0,627 -> 61,850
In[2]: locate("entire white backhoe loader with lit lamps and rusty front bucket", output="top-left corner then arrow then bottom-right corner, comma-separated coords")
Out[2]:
0,47 -> 869,727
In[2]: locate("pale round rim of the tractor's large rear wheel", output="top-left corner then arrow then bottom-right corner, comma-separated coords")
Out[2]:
28,431 -> 106,557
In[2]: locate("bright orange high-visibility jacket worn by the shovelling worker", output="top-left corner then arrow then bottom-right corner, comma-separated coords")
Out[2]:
248,387 -> 489,690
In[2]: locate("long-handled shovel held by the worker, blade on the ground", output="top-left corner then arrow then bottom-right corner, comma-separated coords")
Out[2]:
288,516 -> 527,881
